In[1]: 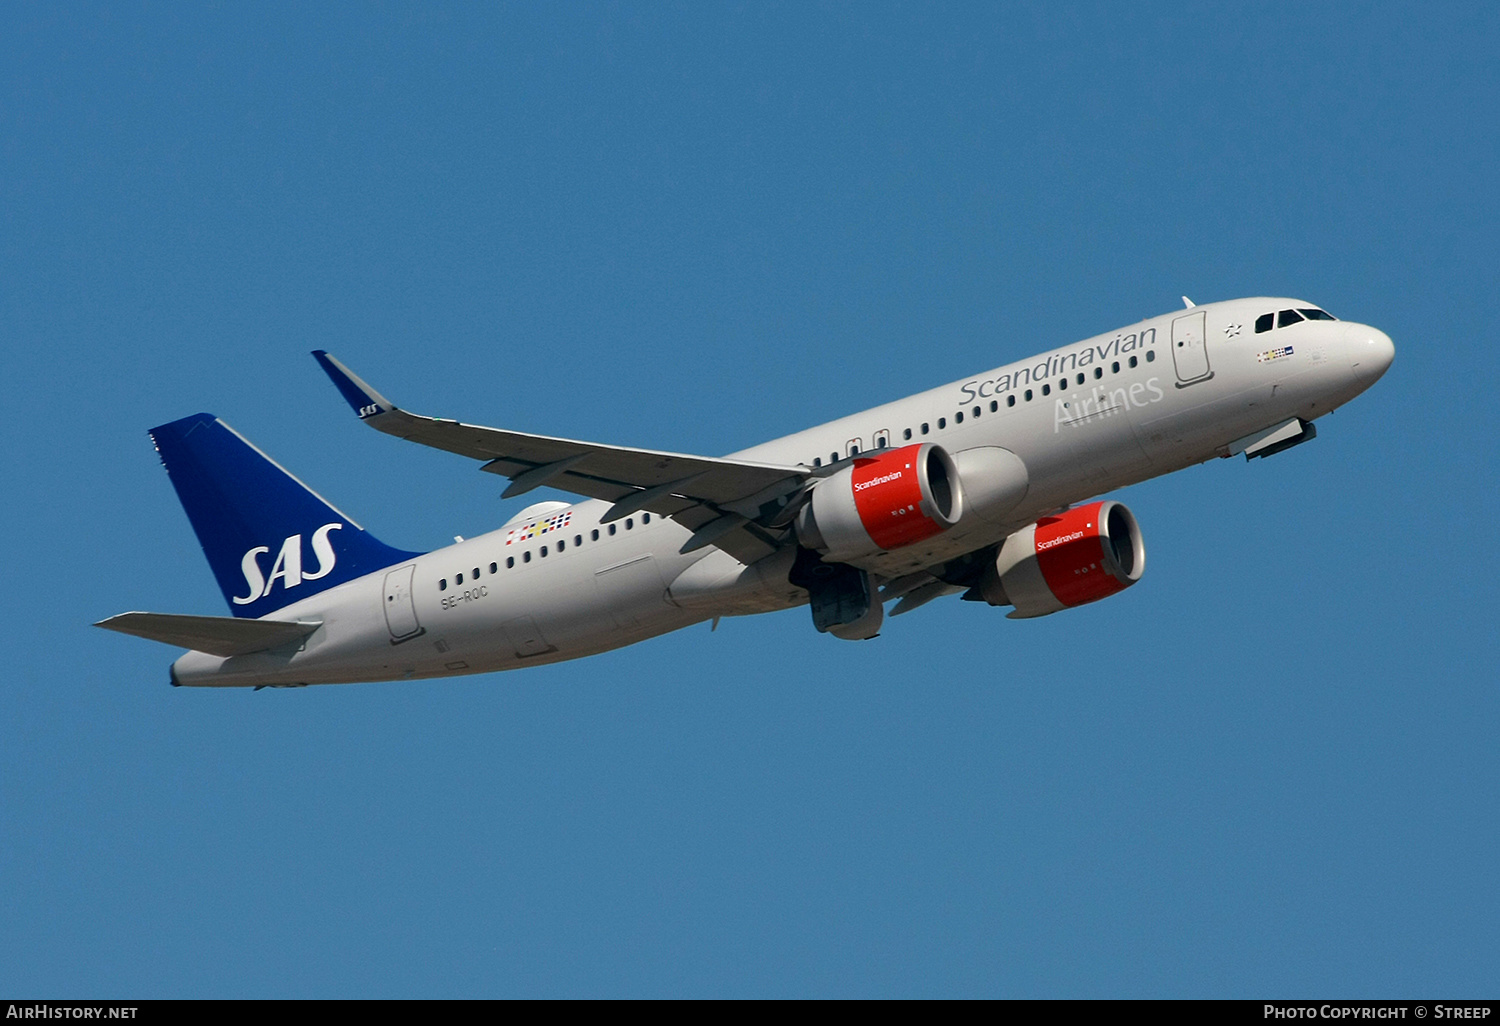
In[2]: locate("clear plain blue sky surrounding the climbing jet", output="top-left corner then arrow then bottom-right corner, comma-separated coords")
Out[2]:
0,3 -> 1500,996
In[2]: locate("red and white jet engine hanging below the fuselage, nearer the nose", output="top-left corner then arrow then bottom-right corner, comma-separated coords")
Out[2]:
980,501 -> 1146,620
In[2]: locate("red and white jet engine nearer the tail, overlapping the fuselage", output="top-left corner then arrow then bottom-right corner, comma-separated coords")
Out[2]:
797,443 -> 963,563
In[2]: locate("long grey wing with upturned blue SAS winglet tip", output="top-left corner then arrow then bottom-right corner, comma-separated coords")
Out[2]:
312,350 -> 828,564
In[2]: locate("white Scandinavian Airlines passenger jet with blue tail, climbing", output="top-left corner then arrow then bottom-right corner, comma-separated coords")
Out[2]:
96,297 -> 1395,689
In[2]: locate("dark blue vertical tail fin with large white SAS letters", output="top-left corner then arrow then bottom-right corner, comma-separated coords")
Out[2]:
150,414 -> 420,617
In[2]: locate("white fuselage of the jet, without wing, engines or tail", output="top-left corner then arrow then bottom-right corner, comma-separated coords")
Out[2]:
173,299 -> 1392,686
